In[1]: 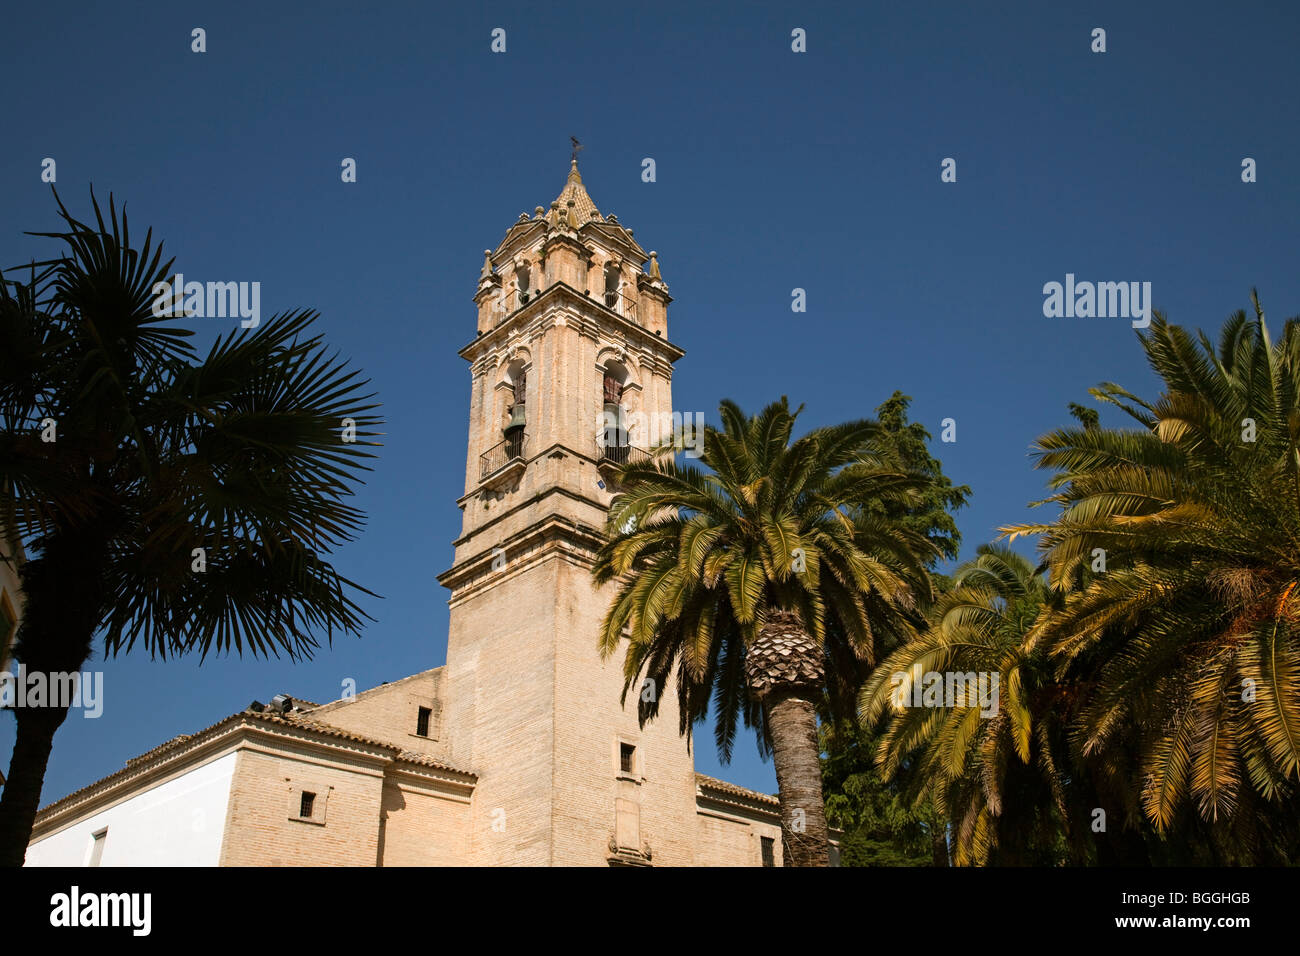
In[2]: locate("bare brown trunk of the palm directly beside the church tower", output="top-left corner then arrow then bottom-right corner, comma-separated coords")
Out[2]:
763,693 -> 831,866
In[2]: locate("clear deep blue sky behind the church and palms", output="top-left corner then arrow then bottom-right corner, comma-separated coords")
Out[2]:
0,1 -> 1300,803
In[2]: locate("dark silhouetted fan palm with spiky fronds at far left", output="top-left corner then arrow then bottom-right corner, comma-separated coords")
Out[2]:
0,194 -> 378,866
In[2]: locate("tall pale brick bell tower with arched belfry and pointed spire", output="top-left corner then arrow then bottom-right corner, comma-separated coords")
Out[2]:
438,152 -> 697,865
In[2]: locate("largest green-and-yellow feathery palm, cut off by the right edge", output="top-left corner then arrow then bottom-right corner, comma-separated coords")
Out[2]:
1009,293 -> 1300,844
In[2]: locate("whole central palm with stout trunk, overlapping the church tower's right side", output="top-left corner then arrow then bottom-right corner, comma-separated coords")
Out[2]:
593,398 -> 933,866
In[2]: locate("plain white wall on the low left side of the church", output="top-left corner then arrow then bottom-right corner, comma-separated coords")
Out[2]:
26,753 -> 235,866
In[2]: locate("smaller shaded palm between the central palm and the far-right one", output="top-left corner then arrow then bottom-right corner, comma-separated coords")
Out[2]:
859,545 -> 1071,865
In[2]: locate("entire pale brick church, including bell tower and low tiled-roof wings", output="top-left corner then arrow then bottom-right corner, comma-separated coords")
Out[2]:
27,157 -> 811,866
